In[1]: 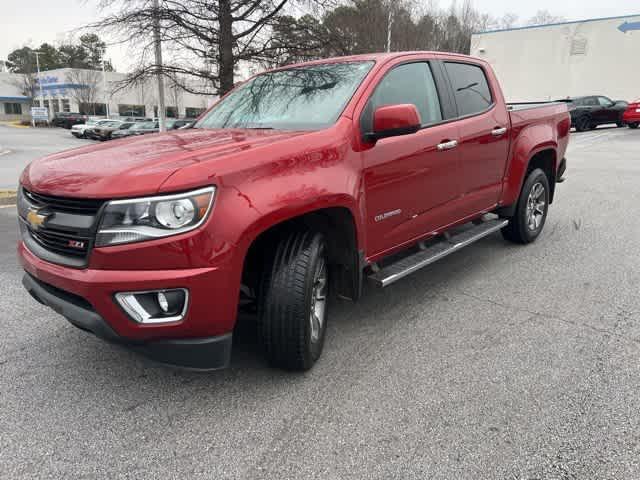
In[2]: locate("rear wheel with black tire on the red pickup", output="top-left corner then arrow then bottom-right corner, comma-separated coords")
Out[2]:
501,168 -> 550,244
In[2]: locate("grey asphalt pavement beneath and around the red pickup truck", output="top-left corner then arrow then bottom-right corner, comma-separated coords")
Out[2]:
0,128 -> 640,480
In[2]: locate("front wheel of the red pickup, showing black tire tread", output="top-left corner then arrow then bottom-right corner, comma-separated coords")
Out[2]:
258,231 -> 329,371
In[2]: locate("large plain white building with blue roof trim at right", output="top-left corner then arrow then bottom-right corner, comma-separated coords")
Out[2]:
470,14 -> 640,102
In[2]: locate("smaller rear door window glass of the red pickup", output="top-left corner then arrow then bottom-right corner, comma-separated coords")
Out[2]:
444,62 -> 493,117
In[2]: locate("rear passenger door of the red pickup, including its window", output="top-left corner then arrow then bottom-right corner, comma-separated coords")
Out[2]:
444,59 -> 510,218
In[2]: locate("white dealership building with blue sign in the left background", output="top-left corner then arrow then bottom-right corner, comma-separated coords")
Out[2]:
0,68 -> 216,124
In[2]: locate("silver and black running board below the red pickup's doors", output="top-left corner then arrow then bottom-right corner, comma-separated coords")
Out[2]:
368,219 -> 509,287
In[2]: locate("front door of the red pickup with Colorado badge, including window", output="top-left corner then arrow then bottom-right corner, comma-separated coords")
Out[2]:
359,60 -> 460,256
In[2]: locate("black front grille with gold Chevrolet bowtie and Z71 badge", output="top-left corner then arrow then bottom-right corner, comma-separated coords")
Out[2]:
18,189 -> 105,268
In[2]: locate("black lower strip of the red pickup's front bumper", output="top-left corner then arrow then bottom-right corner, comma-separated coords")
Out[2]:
22,273 -> 232,370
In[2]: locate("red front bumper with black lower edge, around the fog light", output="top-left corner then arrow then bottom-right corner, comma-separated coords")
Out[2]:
18,242 -> 239,369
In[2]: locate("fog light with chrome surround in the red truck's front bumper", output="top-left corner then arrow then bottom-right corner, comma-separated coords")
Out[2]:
116,288 -> 189,323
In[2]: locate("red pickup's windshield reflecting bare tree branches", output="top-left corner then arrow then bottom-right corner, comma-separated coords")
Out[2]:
195,62 -> 373,130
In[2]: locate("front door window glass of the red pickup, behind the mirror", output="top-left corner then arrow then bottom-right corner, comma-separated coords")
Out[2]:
362,62 -> 442,132
